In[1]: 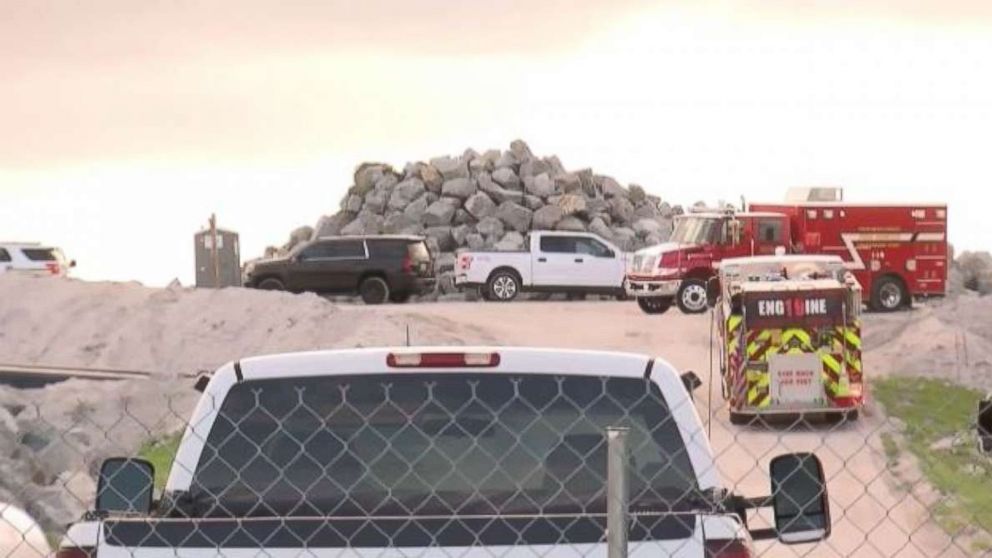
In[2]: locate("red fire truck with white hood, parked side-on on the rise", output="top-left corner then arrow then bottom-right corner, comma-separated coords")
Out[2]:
626,188 -> 948,314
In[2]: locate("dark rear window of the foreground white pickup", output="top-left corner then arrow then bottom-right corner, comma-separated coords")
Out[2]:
190,373 -> 702,517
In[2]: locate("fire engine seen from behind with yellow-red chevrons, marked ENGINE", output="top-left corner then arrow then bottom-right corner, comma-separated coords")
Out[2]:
711,255 -> 864,424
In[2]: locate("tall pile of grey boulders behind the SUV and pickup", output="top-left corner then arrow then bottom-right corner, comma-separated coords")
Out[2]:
266,140 -> 682,294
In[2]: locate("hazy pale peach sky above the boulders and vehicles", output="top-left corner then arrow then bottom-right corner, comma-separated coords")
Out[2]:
0,0 -> 992,284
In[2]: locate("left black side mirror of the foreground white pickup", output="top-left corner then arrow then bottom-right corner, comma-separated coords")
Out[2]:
96,457 -> 155,514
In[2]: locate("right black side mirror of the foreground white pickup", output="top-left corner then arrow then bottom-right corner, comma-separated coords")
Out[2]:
769,453 -> 830,544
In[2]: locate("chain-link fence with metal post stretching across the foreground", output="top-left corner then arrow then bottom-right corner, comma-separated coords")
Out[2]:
0,354 -> 992,558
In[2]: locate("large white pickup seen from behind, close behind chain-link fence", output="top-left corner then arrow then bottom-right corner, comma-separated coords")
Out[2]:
58,347 -> 830,558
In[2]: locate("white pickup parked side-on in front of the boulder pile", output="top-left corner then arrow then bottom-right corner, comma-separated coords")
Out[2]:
455,231 -> 628,302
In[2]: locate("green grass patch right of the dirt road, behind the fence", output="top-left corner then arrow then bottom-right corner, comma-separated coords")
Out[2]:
873,377 -> 992,536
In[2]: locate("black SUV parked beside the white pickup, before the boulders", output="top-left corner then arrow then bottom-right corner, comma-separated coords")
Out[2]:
244,236 -> 436,304
